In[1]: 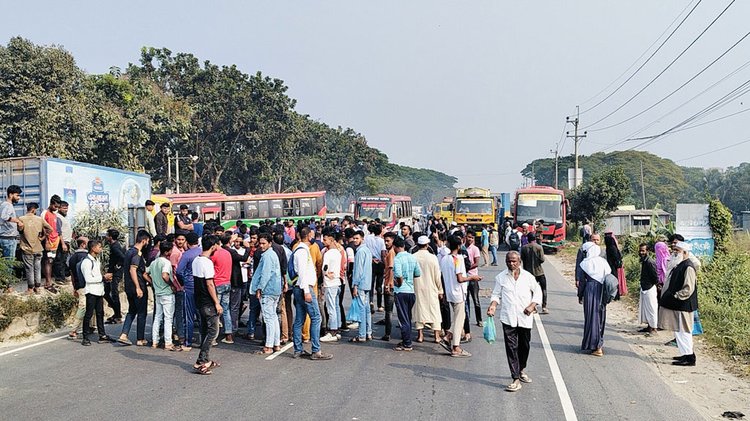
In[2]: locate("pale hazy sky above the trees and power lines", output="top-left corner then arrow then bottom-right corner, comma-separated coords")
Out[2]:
0,0 -> 750,191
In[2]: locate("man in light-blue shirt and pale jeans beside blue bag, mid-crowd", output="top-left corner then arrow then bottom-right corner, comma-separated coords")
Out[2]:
349,231 -> 372,342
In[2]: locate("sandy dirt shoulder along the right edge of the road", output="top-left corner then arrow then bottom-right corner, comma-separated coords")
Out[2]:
546,255 -> 750,419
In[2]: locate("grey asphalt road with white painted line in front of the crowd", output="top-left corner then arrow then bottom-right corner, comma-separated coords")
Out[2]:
0,256 -> 702,421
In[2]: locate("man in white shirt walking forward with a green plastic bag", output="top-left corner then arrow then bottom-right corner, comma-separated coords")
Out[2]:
487,251 -> 542,392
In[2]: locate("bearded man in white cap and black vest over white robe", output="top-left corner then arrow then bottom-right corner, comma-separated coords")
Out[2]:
659,241 -> 698,366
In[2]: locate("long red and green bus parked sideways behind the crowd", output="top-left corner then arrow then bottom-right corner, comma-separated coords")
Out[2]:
152,191 -> 327,229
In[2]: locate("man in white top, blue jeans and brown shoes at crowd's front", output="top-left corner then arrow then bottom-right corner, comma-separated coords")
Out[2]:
293,227 -> 333,360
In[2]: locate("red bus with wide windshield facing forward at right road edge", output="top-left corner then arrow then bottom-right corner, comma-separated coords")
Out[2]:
513,186 -> 570,250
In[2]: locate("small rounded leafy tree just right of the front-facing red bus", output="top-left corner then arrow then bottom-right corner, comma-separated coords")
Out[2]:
569,167 -> 630,227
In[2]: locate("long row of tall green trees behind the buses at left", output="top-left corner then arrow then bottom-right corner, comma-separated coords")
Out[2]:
0,37 -> 456,208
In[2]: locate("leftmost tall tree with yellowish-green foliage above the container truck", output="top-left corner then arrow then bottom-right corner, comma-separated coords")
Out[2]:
0,37 -> 97,161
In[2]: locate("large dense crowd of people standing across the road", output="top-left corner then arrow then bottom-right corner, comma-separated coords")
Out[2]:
44,197 -> 546,376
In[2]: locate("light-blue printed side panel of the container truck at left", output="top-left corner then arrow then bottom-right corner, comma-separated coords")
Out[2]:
46,159 -> 151,219
